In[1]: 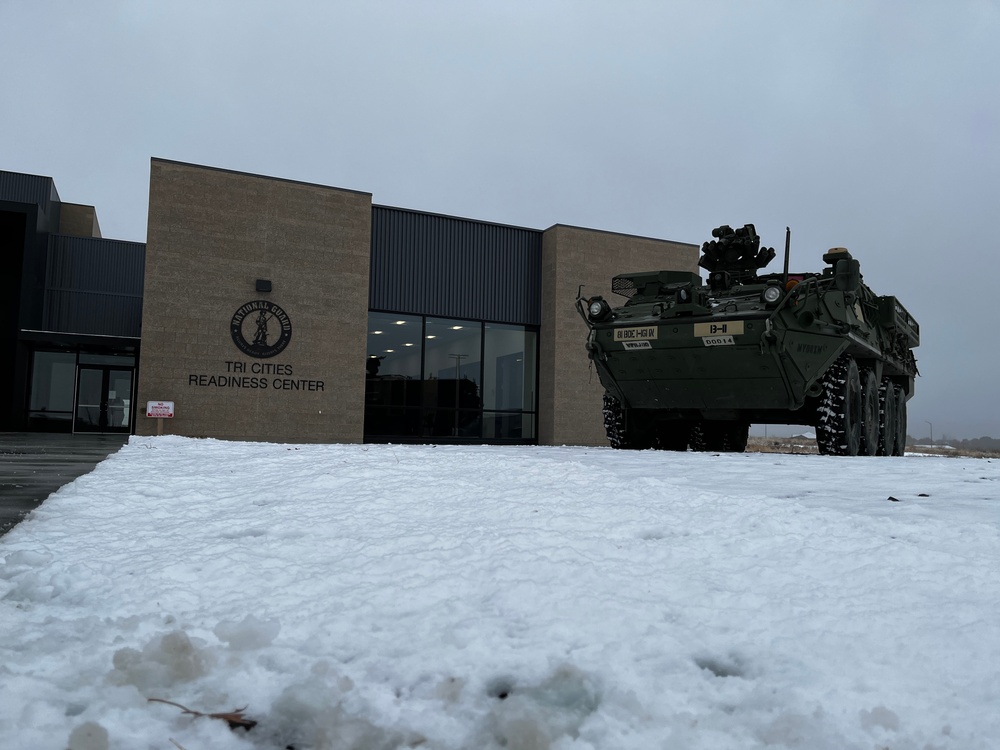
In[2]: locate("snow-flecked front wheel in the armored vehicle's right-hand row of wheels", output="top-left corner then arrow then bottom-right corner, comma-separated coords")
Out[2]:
816,354 -> 864,456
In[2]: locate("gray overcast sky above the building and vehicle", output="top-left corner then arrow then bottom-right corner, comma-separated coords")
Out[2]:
0,0 -> 1000,437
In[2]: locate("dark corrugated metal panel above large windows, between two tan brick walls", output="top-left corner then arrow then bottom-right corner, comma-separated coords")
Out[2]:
368,206 -> 542,325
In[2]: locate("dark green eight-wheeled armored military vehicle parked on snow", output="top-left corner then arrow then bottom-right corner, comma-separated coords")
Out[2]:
577,224 -> 920,456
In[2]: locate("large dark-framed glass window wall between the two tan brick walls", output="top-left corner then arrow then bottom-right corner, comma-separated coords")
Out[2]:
365,312 -> 538,442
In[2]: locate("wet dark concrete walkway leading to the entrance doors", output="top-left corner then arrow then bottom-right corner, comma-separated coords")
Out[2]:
0,432 -> 128,536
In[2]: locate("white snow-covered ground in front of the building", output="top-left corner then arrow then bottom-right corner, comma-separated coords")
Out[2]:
0,437 -> 1000,750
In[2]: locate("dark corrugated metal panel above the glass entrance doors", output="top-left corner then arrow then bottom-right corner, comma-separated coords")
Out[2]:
42,235 -> 146,338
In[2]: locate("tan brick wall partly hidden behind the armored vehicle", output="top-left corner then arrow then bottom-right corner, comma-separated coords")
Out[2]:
538,224 -> 699,445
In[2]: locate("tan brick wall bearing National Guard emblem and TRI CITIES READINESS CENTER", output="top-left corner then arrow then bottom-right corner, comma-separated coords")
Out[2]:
136,159 -> 371,442
